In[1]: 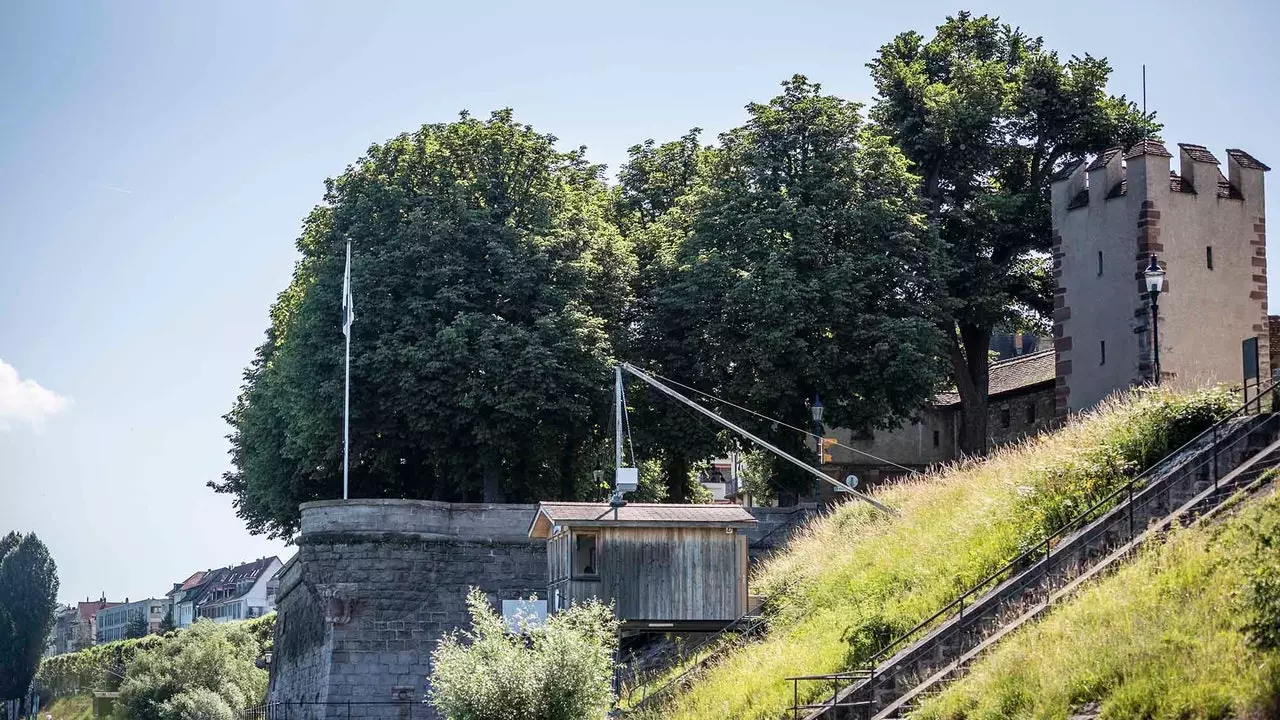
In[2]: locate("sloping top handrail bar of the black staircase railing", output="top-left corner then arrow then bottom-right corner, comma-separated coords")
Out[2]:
787,379 -> 1277,707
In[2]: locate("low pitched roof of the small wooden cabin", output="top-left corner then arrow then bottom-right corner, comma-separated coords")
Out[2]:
529,502 -> 755,538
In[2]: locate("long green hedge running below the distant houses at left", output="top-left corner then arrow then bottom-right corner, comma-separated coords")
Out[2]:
36,612 -> 275,696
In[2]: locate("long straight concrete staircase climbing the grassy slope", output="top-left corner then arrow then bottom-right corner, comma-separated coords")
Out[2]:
790,414 -> 1280,720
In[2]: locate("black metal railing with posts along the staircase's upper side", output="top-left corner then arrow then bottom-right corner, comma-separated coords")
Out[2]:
787,379 -> 1280,714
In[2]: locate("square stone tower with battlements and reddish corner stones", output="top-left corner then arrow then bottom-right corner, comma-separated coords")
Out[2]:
1051,140 -> 1270,415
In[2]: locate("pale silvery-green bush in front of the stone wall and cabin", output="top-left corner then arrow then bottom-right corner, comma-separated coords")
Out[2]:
429,588 -> 617,720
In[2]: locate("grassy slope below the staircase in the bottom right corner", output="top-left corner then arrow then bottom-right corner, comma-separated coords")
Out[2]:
916,481 -> 1280,720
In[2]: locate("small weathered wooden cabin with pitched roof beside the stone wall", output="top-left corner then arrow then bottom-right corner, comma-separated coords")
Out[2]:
529,502 -> 755,630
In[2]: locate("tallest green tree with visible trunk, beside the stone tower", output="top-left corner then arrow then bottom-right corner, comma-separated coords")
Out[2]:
868,13 -> 1157,454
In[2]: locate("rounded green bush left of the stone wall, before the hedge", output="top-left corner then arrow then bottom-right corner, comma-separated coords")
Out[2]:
120,620 -> 268,720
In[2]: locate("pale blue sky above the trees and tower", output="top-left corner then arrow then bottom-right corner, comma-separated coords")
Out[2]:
0,0 -> 1280,601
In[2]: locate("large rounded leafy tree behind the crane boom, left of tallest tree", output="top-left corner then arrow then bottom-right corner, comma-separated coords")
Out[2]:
634,76 -> 941,499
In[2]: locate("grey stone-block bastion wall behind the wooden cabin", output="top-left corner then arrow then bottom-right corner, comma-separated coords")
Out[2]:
269,500 -> 813,720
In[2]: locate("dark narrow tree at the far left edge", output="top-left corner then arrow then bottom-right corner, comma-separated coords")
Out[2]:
0,532 -> 58,700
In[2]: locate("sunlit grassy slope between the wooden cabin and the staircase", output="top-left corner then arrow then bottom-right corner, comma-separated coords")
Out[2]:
654,392 -> 1233,720
